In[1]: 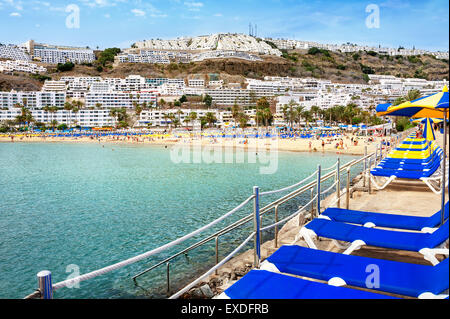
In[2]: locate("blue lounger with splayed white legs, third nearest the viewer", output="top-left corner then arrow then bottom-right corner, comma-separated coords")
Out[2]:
295,217 -> 449,265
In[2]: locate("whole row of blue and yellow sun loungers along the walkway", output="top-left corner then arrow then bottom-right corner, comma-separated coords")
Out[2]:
218,138 -> 449,299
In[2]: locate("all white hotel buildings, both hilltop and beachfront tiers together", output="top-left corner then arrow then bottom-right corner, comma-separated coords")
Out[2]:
0,34 -> 448,127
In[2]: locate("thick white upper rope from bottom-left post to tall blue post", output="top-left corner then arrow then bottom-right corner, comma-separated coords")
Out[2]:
53,195 -> 254,290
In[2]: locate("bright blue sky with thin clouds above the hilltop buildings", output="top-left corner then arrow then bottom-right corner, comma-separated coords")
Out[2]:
0,0 -> 449,51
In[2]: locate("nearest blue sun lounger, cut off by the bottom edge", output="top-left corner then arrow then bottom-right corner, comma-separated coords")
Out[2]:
218,269 -> 394,299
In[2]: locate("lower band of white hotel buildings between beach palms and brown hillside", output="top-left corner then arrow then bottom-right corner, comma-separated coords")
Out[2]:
0,71 -> 448,127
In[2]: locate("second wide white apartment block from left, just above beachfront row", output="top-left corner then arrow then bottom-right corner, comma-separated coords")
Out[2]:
85,91 -> 157,109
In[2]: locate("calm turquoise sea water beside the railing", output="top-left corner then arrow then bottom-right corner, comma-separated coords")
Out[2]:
0,143 -> 354,298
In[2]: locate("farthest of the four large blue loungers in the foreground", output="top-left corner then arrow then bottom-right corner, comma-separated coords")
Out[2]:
321,202 -> 449,232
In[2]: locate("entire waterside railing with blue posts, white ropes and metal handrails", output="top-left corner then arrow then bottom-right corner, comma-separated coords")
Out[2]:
27,153 -> 374,299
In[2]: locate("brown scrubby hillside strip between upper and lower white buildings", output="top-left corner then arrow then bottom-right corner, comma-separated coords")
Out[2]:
0,49 -> 449,90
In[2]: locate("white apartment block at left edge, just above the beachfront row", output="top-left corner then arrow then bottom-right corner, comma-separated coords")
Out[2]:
0,91 -> 66,109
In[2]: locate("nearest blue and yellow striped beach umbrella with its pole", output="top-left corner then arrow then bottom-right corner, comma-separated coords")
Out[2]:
377,86 -> 450,224
